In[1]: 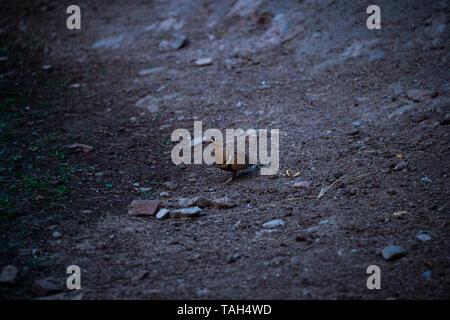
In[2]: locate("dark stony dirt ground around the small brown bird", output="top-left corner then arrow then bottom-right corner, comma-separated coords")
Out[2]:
0,0 -> 450,299
